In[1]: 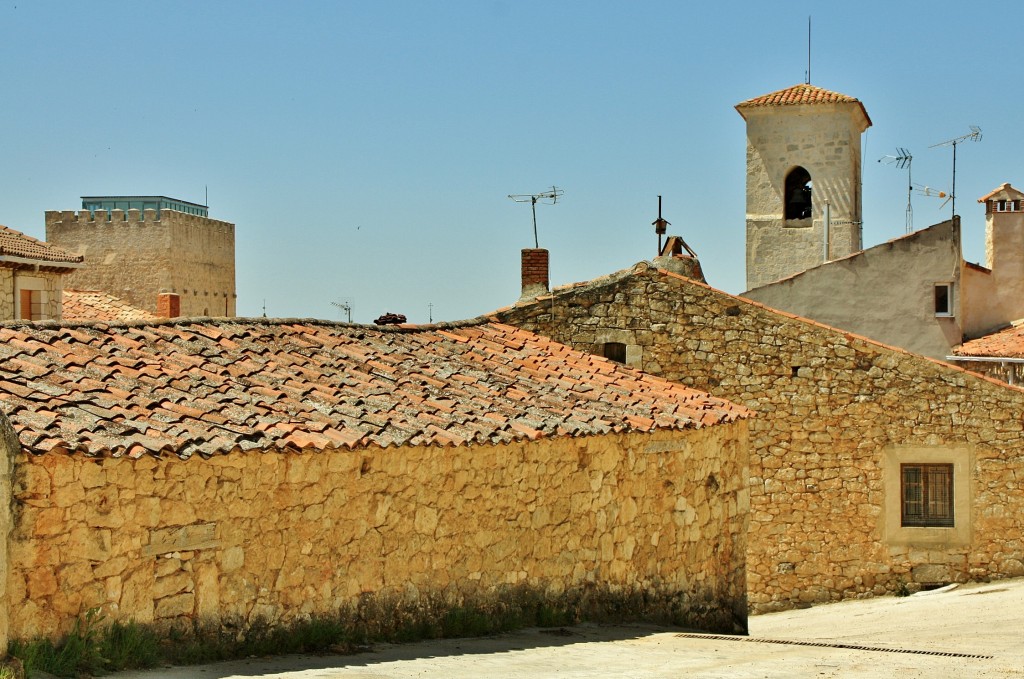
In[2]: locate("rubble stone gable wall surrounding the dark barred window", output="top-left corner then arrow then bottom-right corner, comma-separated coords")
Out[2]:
496,264 -> 1024,611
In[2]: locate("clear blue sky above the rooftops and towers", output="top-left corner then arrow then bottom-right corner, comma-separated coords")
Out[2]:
0,0 -> 1024,323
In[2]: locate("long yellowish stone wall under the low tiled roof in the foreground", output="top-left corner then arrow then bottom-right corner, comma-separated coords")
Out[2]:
0,428 -> 749,638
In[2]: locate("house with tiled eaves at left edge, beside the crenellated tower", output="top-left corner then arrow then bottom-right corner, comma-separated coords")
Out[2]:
0,225 -> 83,321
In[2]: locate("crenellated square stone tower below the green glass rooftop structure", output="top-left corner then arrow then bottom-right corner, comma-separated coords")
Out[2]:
46,210 -> 236,316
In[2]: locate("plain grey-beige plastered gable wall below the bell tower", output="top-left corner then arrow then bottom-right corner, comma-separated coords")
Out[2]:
743,220 -> 967,359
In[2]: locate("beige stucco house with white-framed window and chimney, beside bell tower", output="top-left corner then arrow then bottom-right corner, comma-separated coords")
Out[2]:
742,183 -> 1024,359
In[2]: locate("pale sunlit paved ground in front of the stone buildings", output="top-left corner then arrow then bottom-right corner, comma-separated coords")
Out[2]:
105,580 -> 1024,679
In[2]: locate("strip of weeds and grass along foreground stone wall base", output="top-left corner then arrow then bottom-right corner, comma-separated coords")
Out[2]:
8,588 -> 727,679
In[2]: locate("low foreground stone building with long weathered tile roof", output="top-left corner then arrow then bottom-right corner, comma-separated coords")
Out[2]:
0,320 -> 749,648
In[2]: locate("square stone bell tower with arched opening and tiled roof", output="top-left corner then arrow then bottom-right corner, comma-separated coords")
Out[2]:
736,84 -> 871,290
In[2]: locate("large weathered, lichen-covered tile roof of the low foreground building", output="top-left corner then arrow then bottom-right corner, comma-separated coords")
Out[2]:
0,320 -> 751,458
